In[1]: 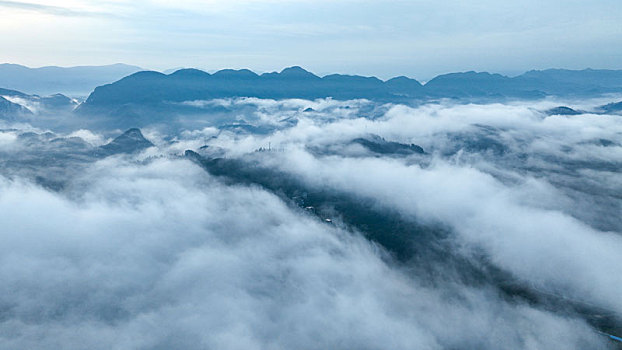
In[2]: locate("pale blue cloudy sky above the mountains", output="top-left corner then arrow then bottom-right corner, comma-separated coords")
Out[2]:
0,0 -> 622,80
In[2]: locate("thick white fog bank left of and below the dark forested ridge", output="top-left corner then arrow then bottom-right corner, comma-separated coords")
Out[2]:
0,158 -> 600,349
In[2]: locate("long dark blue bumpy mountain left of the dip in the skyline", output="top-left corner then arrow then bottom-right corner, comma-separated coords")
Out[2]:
79,67 -> 421,117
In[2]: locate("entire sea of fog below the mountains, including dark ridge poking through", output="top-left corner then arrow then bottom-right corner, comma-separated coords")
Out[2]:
0,99 -> 622,349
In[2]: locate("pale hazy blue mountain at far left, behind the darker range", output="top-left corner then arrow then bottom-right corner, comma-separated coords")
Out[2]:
0,63 -> 142,96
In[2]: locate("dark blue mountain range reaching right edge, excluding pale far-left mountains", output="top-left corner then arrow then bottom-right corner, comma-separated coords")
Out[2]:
79,67 -> 622,113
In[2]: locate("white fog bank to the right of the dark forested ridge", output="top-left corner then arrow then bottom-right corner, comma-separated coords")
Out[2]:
184,98 -> 622,313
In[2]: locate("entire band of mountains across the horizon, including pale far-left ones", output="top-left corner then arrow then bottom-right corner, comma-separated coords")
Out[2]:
0,64 -> 622,128
